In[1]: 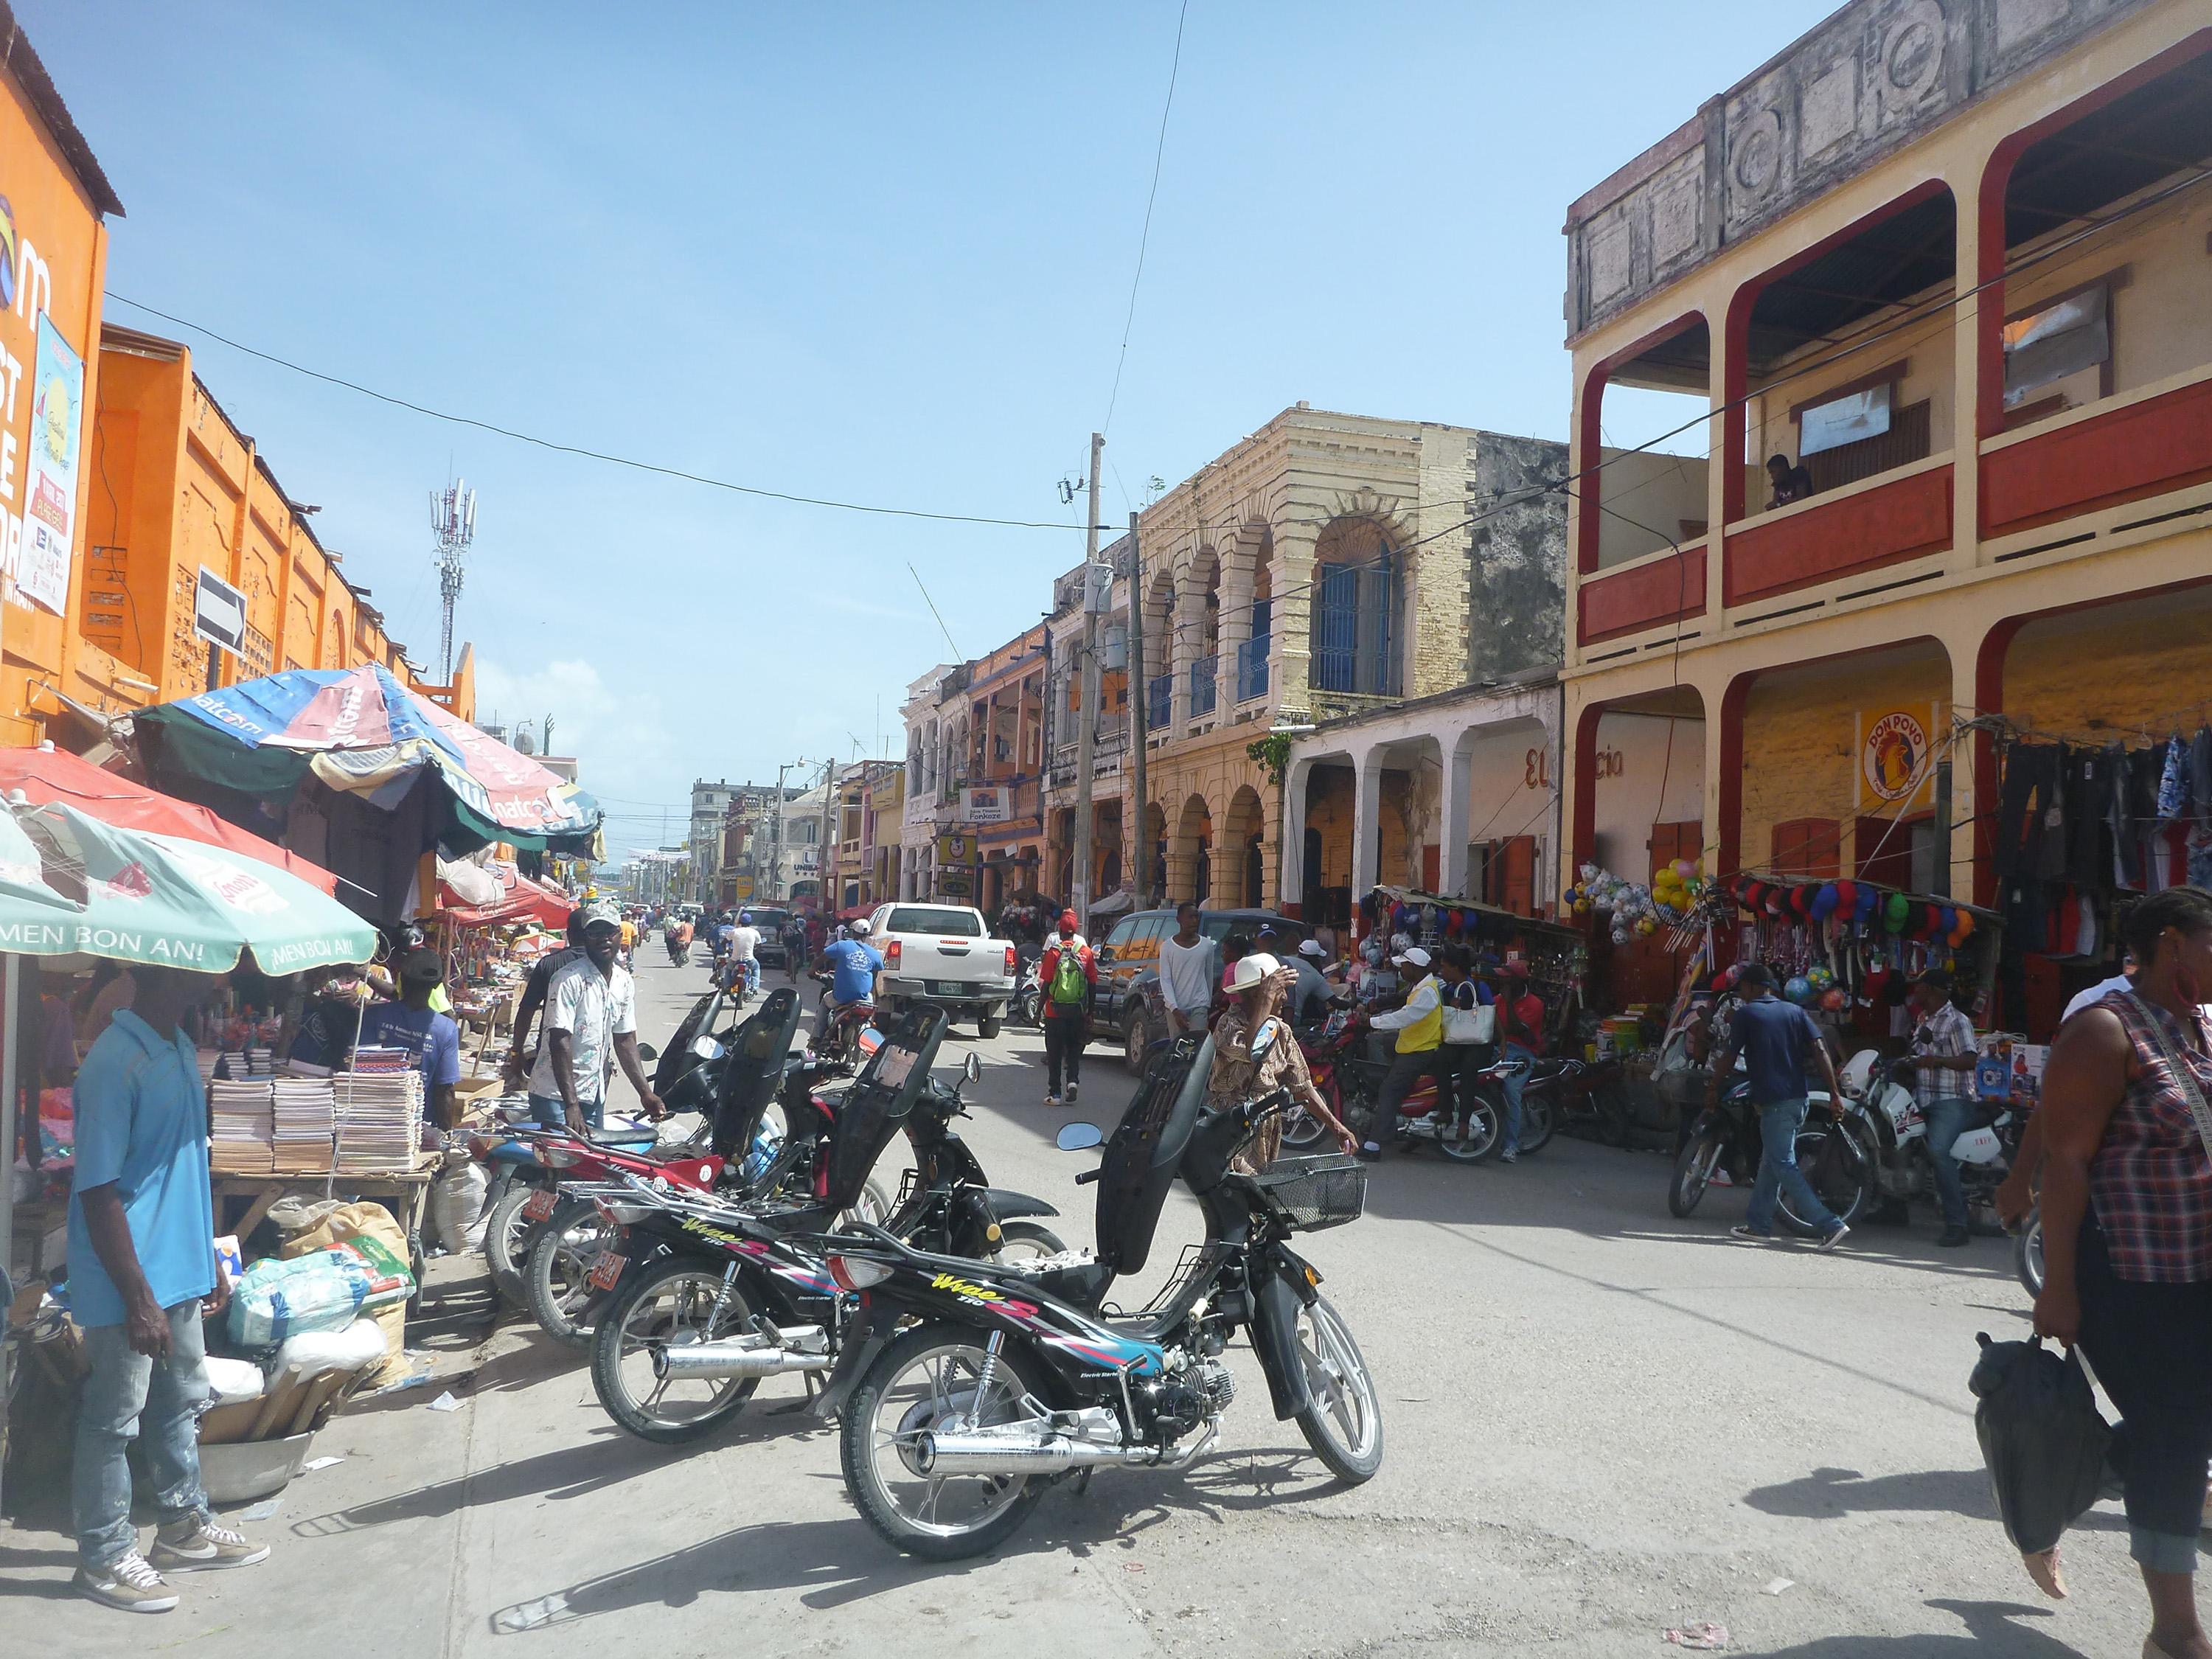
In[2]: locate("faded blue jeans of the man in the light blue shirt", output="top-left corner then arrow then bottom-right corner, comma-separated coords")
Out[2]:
71,1296 -> 215,1573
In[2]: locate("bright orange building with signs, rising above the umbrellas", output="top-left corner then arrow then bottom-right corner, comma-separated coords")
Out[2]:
0,4 -> 476,750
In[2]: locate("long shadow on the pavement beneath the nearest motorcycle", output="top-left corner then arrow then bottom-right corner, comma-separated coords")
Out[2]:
491,1449 -> 1338,1635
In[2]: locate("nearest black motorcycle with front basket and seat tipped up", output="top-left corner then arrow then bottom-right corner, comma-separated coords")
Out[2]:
814,1022 -> 1382,1559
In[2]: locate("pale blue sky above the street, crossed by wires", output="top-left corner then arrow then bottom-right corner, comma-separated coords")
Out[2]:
15,0 -> 1832,856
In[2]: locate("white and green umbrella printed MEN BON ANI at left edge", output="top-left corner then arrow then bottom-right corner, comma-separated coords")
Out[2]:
0,801 -> 376,973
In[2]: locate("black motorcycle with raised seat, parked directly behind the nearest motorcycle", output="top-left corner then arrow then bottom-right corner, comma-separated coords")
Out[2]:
586,1009 -> 1066,1444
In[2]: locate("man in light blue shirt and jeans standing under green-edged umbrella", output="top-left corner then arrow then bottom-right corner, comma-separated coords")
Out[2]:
69,967 -> 268,1613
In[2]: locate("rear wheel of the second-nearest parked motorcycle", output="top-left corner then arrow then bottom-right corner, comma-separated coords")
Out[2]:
591,1256 -> 761,1447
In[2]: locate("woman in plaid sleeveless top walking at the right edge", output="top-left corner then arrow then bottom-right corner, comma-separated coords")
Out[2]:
2026,887 -> 2212,1659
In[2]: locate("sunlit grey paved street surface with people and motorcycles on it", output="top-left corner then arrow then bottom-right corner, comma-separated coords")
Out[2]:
0,953 -> 2141,1659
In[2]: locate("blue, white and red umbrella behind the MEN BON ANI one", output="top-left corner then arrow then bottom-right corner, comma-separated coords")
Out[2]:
137,664 -> 602,856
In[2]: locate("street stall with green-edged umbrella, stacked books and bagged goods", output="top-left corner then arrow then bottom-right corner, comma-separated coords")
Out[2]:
0,799 -> 416,1513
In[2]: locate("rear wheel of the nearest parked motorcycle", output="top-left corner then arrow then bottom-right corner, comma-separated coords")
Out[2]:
838,1323 -> 1046,1562
